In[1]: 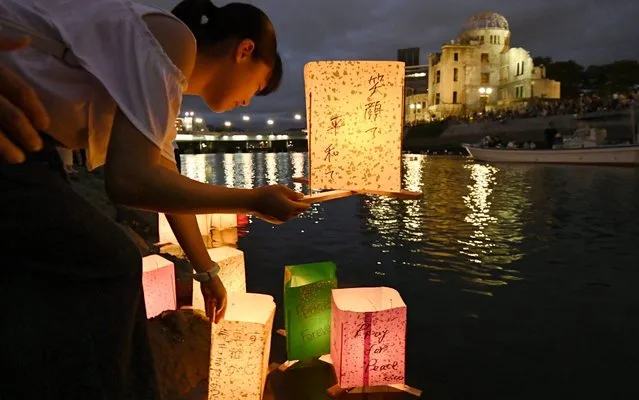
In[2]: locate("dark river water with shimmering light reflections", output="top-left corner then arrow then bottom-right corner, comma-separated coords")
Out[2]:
182,153 -> 639,399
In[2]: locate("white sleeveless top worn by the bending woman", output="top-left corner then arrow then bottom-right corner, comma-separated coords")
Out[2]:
0,0 -> 195,169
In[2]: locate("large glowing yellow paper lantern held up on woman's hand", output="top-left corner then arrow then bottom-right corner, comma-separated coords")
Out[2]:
304,61 -> 404,193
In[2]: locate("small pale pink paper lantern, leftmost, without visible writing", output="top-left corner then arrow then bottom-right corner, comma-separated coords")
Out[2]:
142,254 -> 176,318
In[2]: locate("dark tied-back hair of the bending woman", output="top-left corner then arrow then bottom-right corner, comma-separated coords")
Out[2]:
172,0 -> 282,96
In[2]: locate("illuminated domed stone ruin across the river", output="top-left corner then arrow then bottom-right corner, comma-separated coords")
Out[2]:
427,12 -> 561,118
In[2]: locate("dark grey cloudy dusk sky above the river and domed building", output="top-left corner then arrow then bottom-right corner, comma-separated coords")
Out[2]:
152,0 -> 639,129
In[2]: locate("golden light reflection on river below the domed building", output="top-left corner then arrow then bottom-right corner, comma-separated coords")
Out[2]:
363,155 -> 530,295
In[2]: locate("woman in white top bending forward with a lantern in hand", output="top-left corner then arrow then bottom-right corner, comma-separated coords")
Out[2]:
0,0 -> 308,400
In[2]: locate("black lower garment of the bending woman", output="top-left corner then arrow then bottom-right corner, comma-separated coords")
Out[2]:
0,135 -> 159,400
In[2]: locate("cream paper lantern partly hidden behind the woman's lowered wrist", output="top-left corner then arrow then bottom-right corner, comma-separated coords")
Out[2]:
192,246 -> 246,310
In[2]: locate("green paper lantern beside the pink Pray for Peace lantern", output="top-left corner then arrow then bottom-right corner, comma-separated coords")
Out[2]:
284,262 -> 337,360
